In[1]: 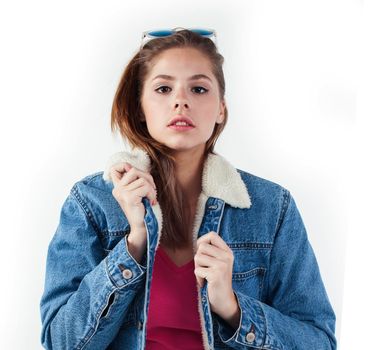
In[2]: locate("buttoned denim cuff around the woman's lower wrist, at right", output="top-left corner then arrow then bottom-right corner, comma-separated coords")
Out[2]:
216,291 -> 266,348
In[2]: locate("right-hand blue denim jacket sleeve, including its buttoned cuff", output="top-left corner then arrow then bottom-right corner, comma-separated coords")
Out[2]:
215,190 -> 336,350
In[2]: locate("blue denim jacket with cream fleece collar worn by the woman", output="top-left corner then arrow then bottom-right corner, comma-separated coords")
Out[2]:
40,149 -> 336,350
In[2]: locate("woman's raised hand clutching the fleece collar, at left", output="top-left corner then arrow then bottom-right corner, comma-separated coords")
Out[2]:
110,162 -> 157,232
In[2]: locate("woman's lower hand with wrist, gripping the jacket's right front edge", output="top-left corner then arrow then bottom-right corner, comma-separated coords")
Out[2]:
194,231 -> 238,319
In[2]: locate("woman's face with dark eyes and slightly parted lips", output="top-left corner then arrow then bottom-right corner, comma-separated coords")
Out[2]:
141,48 -> 225,151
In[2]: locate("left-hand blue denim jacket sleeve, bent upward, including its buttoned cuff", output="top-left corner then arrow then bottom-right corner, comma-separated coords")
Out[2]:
40,185 -> 146,350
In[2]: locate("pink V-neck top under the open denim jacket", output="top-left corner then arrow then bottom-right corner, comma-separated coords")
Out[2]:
146,246 -> 203,350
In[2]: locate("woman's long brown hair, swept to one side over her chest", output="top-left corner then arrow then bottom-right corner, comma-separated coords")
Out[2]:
111,30 -> 228,249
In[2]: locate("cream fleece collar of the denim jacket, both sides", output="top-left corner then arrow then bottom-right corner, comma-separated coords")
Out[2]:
103,147 -> 251,208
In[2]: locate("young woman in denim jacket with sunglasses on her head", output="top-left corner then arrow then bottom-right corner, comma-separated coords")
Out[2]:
41,28 -> 336,350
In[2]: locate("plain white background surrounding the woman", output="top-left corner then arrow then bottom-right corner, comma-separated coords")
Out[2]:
0,0 -> 370,350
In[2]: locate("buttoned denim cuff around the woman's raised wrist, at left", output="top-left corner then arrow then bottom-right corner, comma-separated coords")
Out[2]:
105,235 -> 147,288
